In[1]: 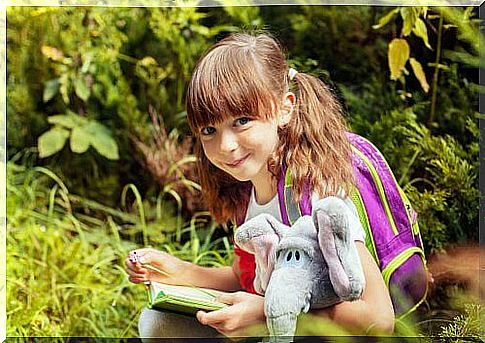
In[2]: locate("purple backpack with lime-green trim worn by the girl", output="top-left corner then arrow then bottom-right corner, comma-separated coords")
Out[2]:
278,133 -> 428,317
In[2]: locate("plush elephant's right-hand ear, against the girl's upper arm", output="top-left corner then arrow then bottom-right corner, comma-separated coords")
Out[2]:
312,197 -> 365,300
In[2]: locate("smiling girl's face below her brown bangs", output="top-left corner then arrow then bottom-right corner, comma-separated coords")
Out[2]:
200,117 -> 278,184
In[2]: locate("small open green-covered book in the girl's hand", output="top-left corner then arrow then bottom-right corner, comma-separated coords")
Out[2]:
147,282 -> 227,315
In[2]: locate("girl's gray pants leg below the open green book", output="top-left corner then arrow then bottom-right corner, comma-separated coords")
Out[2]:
138,308 -> 219,342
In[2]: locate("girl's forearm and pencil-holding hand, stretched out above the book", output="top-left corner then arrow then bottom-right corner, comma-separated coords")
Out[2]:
125,248 -> 241,291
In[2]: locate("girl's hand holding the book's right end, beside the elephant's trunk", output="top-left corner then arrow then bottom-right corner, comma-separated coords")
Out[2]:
197,292 -> 267,337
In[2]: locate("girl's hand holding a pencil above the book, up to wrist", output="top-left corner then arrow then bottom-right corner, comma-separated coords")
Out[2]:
125,248 -> 192,285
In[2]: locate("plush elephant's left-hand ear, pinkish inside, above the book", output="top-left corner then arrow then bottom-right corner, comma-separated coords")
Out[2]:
234,214 -> 287,294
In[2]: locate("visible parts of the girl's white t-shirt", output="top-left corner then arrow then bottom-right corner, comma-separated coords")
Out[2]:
245,187 -> 365,242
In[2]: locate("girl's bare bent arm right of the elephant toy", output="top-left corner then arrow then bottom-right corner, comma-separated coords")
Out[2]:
311,241 -> 394,335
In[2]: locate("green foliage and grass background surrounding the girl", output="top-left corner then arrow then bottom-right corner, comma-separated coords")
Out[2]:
7,6 -> 484,337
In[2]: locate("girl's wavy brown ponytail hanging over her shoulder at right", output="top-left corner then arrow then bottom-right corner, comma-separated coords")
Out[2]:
279,73 -> 354,201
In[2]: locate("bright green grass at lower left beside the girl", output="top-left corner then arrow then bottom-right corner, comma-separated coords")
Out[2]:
7,164 -> 232,338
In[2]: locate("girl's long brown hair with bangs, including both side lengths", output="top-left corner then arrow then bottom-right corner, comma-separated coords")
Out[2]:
186,33 -> 353,223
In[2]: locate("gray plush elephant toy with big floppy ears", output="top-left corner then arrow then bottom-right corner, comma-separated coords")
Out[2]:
235,197 -> 365,341
